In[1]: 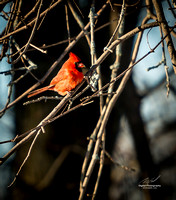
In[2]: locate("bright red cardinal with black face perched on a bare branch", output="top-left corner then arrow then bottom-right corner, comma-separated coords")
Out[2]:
28,52 -> 85,98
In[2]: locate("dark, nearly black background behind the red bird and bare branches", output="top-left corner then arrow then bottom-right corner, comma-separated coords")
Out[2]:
1,1 -> 176,200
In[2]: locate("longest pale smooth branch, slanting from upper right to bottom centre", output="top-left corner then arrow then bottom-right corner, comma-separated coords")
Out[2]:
79,11 -> 158,200
